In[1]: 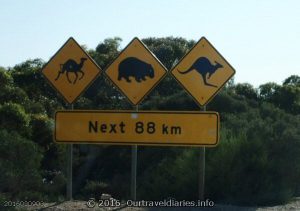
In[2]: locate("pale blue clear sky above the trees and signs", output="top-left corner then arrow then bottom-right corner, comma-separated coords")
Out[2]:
0,0 -> 300,87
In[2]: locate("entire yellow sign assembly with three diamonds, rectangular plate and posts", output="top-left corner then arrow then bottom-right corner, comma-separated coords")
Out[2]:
42,37 -> 235,200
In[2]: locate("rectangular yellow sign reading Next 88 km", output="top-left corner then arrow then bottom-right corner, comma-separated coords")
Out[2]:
54,110 -> 219,146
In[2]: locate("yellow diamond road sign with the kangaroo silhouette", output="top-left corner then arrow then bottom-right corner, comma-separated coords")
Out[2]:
171,37 -> 235,106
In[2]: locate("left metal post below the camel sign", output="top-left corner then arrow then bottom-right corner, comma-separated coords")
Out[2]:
67,104 -> 74,201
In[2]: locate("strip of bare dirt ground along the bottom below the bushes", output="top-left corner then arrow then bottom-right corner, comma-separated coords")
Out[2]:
17,197 -> 300,211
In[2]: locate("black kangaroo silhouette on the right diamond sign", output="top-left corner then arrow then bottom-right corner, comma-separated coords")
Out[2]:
178,57 -> 223,87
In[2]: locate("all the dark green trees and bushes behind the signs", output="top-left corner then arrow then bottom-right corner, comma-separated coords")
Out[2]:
0,37 -> 300,205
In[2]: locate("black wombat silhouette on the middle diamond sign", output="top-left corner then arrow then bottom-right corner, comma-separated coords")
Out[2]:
118,57 -> 154,83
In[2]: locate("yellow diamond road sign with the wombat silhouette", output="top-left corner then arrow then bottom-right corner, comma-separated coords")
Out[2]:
105,38 -> 167,105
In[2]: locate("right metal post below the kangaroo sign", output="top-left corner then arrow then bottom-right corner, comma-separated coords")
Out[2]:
199,106 -> 206,200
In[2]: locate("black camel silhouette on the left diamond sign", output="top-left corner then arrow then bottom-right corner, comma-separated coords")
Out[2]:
55,58 -> 87,84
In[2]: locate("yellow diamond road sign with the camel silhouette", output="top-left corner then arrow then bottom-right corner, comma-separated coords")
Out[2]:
42,37 -> 101,103
